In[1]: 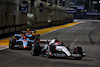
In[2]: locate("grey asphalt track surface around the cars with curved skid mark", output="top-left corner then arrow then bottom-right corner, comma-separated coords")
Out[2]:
0,20 -> 100,67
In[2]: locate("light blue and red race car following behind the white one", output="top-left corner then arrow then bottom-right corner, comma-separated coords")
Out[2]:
9,31 -> 40,49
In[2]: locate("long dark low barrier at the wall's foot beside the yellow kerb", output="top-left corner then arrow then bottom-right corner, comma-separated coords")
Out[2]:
0,20 -> 73,38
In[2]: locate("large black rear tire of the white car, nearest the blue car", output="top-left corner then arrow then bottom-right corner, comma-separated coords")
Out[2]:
31,43 -> 41,56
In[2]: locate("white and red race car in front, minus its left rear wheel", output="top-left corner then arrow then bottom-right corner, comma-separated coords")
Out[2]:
31,39 -> 85,60
